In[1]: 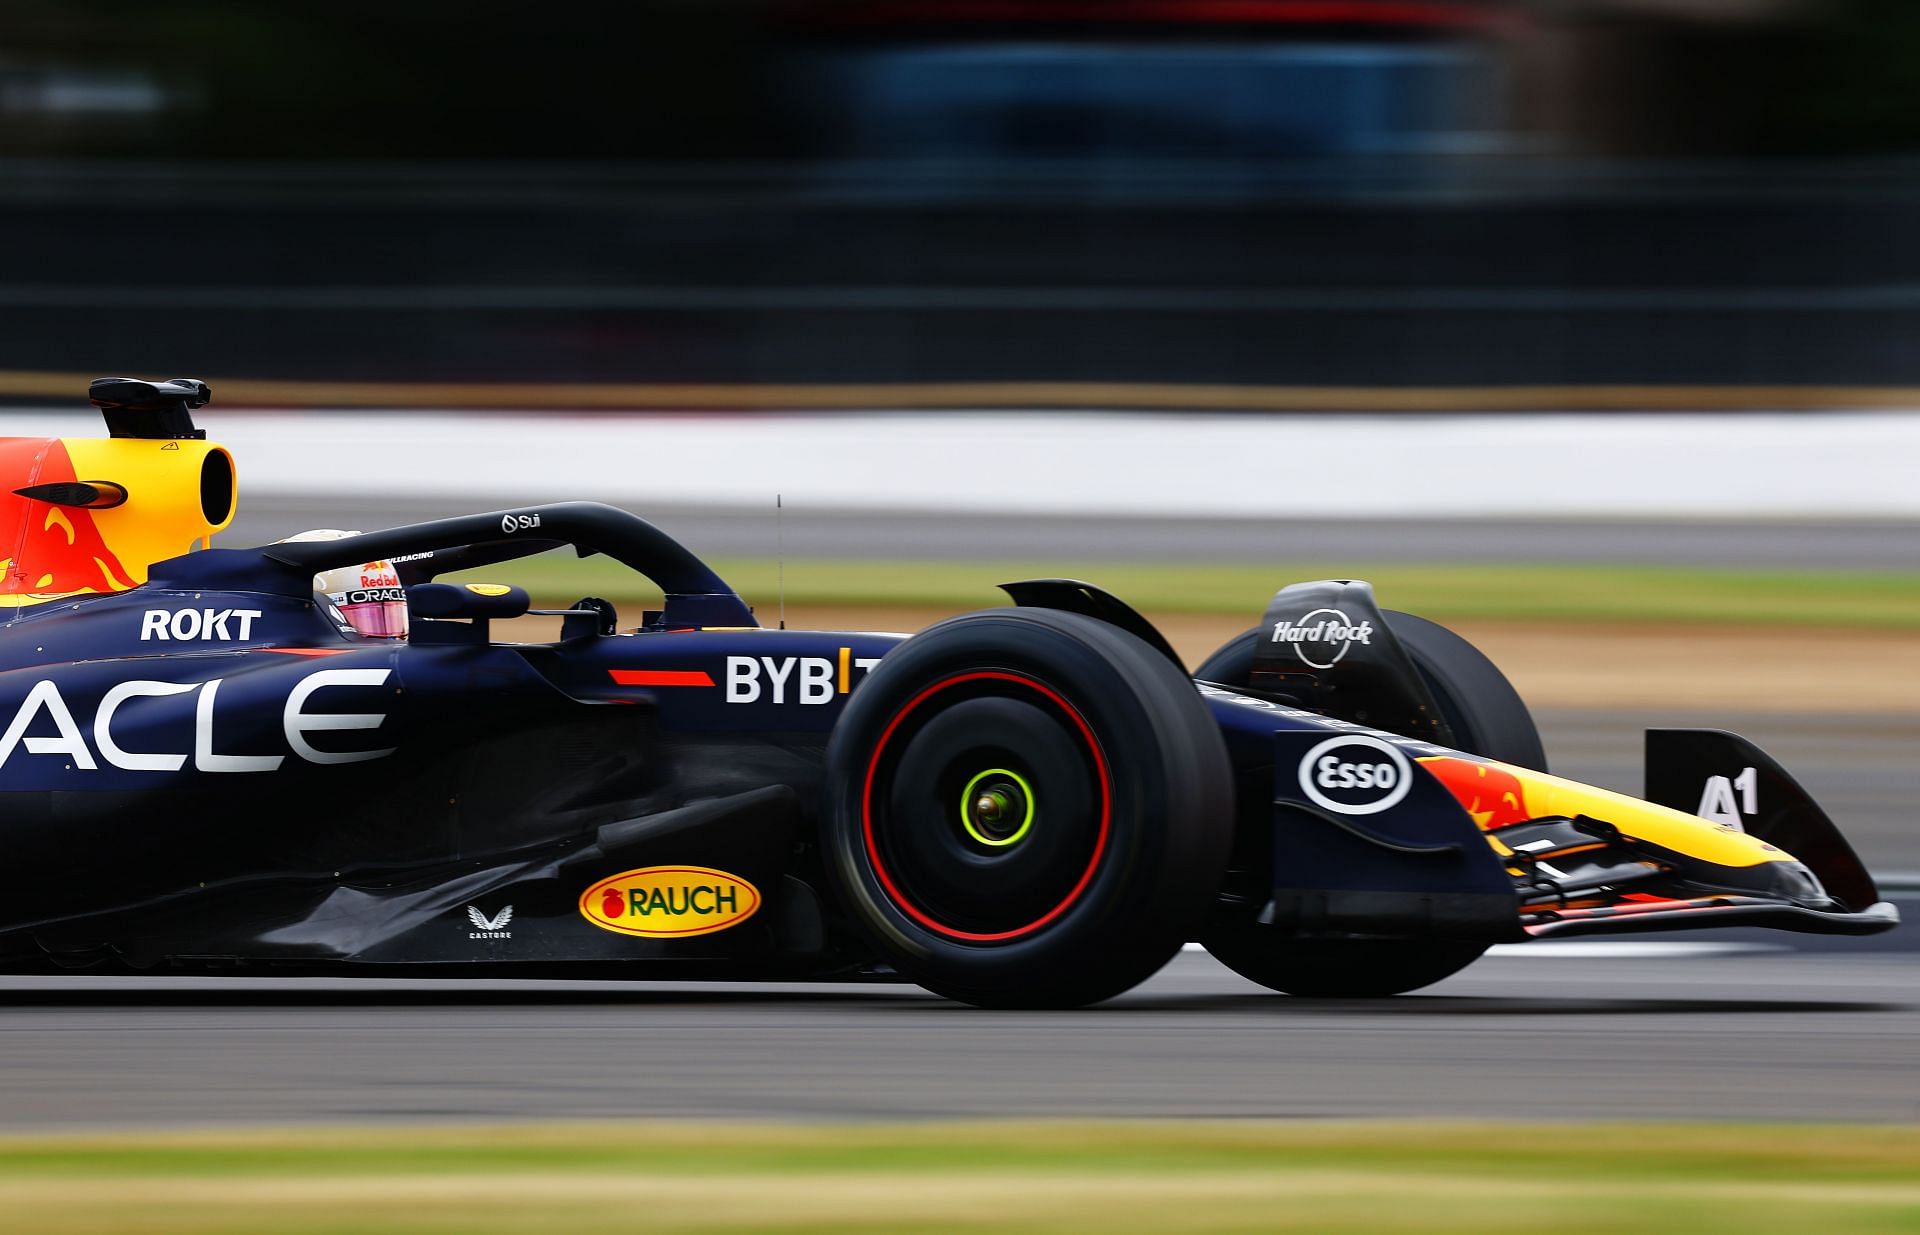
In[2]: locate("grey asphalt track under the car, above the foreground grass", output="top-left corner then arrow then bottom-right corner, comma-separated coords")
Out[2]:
0,945 -> 1920,1131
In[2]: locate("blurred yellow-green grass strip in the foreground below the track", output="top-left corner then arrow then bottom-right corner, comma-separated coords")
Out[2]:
0,1122 -> 1920,1235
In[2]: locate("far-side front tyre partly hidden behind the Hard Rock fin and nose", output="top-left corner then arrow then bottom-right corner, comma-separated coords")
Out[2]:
1194,609 -> 1548,999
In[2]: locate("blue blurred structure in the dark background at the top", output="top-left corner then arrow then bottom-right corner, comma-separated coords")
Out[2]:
806,42 -> 1503,163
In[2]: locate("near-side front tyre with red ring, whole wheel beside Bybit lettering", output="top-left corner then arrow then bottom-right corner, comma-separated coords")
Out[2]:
824,609 -> 1233,1006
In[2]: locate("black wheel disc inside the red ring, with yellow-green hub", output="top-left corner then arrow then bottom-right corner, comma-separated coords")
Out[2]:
860,670 -> 1114,943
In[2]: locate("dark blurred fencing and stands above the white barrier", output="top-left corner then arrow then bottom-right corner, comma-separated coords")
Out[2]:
11,0 -> 1920,386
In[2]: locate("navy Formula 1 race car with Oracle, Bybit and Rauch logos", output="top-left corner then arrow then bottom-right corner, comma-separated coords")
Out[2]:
0,378 -> 1897,1006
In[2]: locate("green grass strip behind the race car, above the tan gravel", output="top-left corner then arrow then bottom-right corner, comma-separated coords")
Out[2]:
453,555 -> 1920,630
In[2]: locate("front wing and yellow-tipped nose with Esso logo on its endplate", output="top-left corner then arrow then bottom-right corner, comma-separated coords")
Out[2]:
1258,730 -> 1899,941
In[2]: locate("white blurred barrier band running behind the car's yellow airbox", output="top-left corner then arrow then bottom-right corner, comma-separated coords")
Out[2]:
11,405 -> 1920,517
